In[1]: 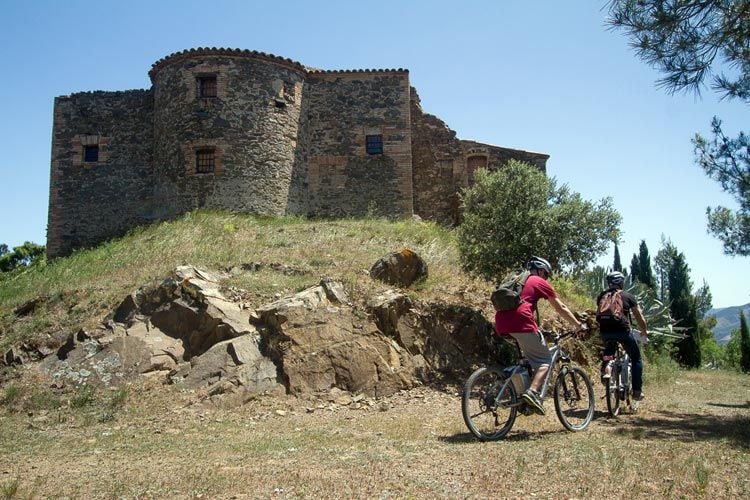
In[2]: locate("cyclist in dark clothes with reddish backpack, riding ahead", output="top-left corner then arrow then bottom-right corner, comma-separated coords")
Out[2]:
596,271 -> 648,401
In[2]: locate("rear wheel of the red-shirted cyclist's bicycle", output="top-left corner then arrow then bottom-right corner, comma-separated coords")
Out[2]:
461,368 -> 518,441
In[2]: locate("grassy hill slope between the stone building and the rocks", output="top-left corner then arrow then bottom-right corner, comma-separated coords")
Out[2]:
0,211 -> 590,352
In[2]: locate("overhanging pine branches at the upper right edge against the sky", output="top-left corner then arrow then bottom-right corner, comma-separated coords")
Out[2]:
607,0 -> 750,256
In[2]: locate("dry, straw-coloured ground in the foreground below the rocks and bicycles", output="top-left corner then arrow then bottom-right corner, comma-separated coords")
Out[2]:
0,371 -> 750,499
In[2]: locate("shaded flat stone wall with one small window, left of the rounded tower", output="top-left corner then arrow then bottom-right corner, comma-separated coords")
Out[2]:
47,90 -> 153,256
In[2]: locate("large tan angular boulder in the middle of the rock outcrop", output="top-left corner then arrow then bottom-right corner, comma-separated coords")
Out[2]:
257,281 -> 414,396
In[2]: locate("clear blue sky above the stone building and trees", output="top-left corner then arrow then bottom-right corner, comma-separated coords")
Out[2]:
0,0 -> 750,307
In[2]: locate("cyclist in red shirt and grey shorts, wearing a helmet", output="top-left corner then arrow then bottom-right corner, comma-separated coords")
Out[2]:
495,257 -> 587,415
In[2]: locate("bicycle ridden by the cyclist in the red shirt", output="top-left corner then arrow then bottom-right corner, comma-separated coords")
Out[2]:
461,331 -> 594,441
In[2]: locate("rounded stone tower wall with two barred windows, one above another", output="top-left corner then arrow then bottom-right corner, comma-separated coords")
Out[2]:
151,52 -> 304,217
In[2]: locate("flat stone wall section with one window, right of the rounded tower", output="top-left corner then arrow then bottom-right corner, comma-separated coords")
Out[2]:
302,70 -> 413,217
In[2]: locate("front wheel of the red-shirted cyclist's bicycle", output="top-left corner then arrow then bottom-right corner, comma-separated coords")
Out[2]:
554,365 -> 594,432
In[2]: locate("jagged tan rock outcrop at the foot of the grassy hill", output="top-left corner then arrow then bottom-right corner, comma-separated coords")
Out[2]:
35,266 -> 492,402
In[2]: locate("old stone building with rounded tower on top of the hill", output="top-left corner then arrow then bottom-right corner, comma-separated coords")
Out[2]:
47,48 -> 549,257
